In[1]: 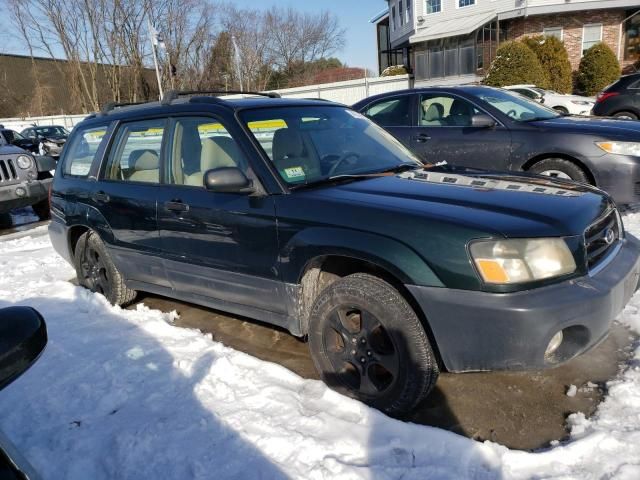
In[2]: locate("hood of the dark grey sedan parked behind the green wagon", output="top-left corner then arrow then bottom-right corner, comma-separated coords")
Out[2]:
528,116 -> 640,141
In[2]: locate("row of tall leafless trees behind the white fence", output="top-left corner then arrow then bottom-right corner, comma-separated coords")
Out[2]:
8,0 -> 344,113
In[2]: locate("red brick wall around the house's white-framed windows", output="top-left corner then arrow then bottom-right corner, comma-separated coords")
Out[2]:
506,10 -> 630,70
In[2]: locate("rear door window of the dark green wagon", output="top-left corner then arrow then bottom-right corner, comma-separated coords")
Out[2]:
104,119 -> 165,183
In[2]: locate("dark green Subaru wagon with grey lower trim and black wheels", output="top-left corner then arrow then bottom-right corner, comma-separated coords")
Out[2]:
49,93 -> 640,413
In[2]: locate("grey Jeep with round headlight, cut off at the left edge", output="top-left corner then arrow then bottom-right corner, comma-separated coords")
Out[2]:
0,134 -> 56,223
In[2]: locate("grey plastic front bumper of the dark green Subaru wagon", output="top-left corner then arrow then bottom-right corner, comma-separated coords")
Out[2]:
407,235 -> 640,372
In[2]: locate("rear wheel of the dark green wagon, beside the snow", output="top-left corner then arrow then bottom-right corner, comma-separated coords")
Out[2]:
73,232 -> 137,307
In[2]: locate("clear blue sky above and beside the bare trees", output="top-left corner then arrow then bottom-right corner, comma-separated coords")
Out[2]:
0,0 -> 386,72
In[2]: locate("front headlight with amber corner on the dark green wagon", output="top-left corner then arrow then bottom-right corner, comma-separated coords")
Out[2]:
469,238 -> 576,285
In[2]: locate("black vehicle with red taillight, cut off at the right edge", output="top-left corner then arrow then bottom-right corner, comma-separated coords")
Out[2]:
591,73 -> 640,120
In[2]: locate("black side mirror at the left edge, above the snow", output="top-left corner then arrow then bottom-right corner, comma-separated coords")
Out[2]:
0,307 -> 47,390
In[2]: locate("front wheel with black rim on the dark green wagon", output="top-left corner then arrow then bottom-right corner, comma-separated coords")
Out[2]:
309,273 -> 439,414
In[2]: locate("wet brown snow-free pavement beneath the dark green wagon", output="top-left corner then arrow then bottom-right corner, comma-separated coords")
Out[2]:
132,295 -> 635,449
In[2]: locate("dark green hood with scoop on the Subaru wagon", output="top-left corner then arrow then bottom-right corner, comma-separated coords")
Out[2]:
308,167 -> 612,237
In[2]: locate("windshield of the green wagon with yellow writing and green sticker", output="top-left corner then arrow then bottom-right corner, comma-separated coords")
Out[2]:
241,106 -> 422,185
